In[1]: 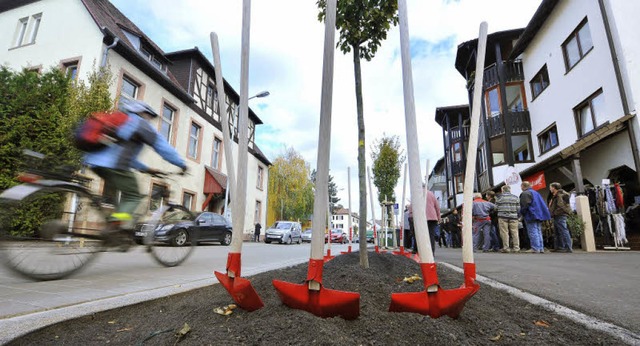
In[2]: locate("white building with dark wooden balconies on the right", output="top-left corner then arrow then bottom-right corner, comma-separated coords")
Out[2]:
436,0 -> 640,247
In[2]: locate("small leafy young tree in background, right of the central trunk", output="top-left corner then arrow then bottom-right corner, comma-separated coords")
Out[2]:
371,134 -> 405,230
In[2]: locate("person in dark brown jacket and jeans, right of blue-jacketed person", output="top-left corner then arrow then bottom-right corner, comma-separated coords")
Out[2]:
549,183 -> 573,252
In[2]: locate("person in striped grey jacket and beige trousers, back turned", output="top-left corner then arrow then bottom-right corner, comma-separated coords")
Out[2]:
496,185 -> 520,253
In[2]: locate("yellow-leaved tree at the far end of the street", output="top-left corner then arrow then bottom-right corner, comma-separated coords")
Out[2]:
269,148 -> 313,220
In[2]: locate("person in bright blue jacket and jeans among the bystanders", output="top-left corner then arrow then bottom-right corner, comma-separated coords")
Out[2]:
520,181 -> 551,253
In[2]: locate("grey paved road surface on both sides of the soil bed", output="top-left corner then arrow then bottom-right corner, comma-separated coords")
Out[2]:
0,243 -> 640,344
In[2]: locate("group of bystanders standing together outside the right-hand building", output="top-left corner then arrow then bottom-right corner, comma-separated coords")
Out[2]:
471,181 -> 573,253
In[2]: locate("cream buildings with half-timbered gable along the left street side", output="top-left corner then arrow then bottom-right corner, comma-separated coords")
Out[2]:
0,0 -> 270,238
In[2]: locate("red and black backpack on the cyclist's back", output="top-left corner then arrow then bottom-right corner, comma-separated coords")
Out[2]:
73,111 -> 129,152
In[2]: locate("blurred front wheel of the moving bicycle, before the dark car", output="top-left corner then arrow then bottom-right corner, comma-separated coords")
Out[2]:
144,205 -> 199,267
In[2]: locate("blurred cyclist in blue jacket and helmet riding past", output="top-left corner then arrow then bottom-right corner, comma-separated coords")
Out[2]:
84,99 -> 187,230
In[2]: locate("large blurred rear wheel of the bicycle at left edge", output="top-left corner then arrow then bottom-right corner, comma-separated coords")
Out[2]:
0,185 -> 105,280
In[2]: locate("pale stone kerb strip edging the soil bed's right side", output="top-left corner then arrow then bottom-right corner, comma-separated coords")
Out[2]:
438,262 -> 640,345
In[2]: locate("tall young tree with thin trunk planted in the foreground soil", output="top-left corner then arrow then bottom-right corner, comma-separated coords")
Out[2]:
316,0 -> 398,268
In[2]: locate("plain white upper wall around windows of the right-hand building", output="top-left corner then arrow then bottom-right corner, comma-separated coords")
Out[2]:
521,0 -> 624,162
